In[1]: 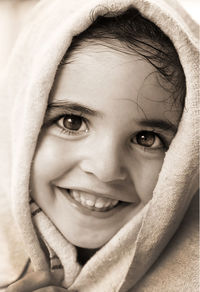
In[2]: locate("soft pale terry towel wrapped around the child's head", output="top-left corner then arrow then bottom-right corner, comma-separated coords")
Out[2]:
0,0 -> 198,292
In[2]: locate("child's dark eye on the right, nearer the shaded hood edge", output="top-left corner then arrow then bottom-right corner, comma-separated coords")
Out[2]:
132,131 -> 164,149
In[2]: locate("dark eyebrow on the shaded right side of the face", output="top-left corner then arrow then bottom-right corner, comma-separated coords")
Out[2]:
138,119 -> 177,134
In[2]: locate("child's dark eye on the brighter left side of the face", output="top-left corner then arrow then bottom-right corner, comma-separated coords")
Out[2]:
58,115 -> 87,132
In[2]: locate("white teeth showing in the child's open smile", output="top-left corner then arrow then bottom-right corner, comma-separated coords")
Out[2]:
70,190 -> 119,211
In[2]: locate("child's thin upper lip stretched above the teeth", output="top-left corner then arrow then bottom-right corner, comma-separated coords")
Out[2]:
57,186 -> 136,203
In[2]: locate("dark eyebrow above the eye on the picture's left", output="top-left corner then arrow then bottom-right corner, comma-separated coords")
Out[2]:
47,100 -> 101,116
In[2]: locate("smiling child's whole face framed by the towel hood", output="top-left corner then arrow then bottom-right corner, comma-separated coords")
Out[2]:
31,45 -> 181,248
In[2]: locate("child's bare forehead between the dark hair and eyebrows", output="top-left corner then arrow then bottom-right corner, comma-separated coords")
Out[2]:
51,43 -> 181,122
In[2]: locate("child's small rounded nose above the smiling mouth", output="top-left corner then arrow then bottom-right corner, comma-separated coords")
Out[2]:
80,139 -> 127,182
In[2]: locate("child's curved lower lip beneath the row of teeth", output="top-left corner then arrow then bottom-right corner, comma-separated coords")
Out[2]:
58,188 -> 131,218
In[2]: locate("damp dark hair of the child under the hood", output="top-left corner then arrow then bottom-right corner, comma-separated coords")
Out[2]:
61,8 -> 186,108
